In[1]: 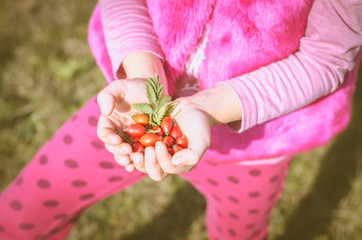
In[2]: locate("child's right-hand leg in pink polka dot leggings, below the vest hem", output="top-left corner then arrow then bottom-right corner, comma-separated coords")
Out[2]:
183,157 -> 291,240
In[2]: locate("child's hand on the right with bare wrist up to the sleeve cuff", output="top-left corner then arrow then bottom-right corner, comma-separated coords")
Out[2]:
132,84 -> 241,180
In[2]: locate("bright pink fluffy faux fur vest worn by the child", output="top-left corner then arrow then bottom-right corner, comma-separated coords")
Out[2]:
89,0 -> 356,162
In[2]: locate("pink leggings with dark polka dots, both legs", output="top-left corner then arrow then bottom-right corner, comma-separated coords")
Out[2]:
0,98 -> 290,240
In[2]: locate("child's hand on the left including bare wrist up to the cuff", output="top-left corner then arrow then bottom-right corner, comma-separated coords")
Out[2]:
97,51 -> 168,171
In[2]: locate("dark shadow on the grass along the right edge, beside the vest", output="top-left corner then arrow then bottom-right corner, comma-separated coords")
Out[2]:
278,68 -> 362,240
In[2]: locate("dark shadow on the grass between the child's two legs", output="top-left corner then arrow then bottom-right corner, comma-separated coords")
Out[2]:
122,183 -> 206,240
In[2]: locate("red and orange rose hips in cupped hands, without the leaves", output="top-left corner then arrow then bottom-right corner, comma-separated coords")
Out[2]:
121,114 -> 188,155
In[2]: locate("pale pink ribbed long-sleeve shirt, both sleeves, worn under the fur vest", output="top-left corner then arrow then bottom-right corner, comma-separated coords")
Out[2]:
100,0 -> 362,132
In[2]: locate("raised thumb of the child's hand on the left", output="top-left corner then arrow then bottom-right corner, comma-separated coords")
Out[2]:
97,81 -> 126,116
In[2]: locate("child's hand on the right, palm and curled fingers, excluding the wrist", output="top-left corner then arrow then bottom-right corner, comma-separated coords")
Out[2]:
131,97 -> 211,181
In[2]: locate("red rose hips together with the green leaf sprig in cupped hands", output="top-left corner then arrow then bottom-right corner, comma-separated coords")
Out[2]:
118,75 -> 188,155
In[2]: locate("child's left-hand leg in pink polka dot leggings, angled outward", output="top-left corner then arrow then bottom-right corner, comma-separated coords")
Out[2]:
0,98 -> 144,240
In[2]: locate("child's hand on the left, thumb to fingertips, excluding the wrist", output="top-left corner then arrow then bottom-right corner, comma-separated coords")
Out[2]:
97,79 -> 147,171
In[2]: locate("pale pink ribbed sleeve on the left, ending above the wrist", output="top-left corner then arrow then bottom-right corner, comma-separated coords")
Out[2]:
99,0 -> 163,78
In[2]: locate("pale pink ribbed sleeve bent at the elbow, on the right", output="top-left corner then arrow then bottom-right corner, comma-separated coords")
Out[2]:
223,0 -> 362,132
